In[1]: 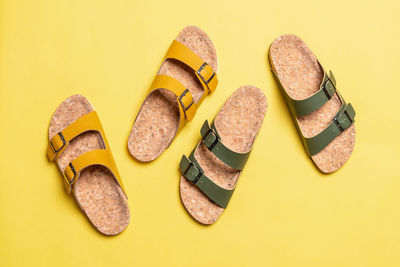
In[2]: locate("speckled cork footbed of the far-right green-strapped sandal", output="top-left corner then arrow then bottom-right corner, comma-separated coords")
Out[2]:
269,34 -> 356,173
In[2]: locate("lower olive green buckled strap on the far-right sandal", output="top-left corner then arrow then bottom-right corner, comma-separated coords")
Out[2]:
303,99 -> 356,156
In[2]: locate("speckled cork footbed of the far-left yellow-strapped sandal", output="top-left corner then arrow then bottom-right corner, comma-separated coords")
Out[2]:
49,95 -> 130,235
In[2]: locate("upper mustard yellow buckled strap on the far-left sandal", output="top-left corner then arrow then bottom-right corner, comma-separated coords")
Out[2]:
47,111 -> 108,161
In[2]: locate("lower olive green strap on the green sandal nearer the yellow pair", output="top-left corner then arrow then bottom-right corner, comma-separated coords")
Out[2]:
179,149 -> 234,209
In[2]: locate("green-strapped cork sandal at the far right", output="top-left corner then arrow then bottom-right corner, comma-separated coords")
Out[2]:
269,35 -> 356,173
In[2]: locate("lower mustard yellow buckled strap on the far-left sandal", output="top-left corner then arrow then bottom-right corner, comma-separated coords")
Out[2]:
63,149 -> 126,196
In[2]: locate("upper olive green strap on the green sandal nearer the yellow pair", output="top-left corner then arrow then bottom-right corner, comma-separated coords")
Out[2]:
200,120 -> 251,170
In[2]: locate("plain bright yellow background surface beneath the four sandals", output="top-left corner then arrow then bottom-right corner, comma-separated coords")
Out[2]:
0,0 -> 400,267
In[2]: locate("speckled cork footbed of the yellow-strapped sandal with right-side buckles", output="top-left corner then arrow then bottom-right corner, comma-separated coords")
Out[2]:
128,26 -> 218,162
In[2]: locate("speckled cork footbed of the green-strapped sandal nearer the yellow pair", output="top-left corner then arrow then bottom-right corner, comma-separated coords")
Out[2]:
180,86 -> 267,224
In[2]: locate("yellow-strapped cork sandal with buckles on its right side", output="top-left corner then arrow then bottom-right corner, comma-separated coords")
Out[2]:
128,26 -> 218,162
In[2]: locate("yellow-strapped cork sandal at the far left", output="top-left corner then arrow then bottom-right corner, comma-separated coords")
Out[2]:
47,95 -> 130,235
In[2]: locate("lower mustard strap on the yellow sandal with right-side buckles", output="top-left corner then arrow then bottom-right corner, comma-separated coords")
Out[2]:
150,74 -> 197,121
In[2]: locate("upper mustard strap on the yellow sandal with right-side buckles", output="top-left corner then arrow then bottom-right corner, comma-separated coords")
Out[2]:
164,40 -> 218,95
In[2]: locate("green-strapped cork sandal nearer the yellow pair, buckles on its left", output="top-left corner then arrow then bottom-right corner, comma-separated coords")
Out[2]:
179,86 -> 267,224
